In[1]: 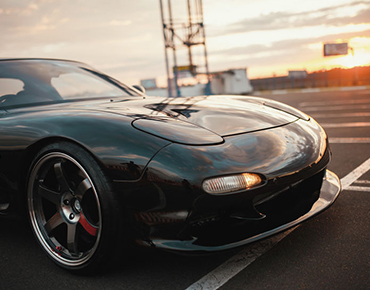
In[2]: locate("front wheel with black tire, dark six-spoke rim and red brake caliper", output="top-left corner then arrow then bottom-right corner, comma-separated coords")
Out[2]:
27,142 -> 122,274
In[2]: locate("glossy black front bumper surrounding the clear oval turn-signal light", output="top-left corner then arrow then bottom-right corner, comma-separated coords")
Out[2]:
120,116 -> 330,250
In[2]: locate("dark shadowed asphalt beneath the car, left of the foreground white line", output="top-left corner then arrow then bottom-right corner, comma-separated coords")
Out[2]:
0,219 -> 237,289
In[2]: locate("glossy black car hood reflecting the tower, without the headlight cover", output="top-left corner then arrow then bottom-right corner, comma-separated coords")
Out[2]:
89,96 -> 299,137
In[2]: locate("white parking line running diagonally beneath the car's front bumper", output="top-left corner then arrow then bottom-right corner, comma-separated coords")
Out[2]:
186,158 -> 370,290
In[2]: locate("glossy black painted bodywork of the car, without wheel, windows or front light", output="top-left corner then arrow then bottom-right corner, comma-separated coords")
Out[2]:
0,60 -> 340,251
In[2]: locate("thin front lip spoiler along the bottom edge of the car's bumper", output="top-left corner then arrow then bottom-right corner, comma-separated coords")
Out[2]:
139,170 -> 341,252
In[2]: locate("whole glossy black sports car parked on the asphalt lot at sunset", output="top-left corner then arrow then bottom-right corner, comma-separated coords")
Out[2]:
0,59 -> 340,271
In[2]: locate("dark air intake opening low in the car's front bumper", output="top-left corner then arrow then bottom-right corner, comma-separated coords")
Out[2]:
189,170 -> 325,246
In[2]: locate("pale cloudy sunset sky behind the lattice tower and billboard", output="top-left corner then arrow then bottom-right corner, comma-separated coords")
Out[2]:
0,0 -> 370,85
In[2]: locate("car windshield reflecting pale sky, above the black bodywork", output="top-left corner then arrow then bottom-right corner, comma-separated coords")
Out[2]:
0,60 -> 139,108
